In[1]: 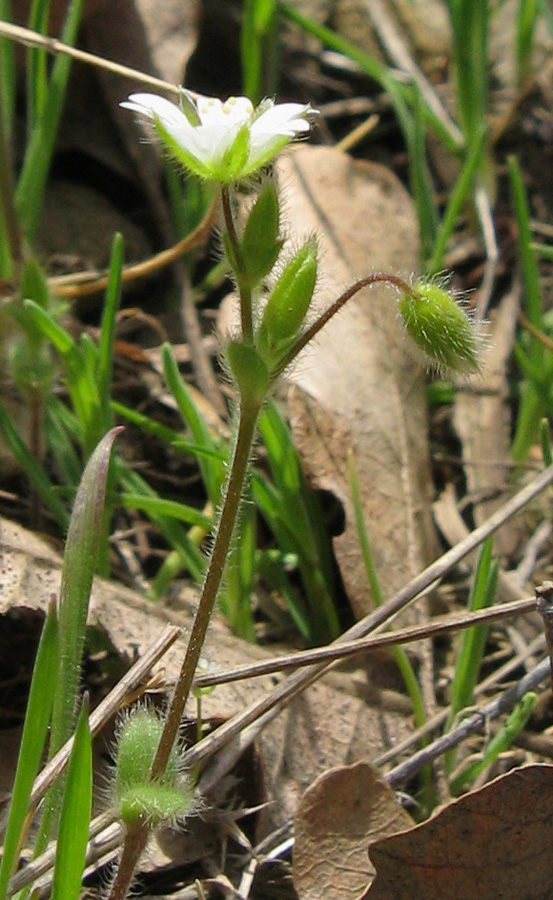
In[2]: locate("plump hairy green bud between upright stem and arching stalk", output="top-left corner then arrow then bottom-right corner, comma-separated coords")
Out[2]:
256,238 -> 317,369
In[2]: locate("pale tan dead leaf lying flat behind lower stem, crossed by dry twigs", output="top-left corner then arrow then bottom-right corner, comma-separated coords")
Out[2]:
0,519 -> 408,829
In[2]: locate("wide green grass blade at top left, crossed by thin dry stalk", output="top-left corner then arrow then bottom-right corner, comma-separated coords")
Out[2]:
16,0 -> 84,242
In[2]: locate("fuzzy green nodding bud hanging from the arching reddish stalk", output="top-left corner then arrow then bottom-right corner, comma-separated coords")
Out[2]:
398,279 -> 481,374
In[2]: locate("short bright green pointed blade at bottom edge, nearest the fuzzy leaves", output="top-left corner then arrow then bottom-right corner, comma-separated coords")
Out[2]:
52,696 -> 92,900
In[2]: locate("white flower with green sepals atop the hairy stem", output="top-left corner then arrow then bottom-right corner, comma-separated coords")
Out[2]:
120,89 -> 316,184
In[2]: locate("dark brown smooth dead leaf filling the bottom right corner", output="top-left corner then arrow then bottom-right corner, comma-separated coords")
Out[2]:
367,765 -> 553,900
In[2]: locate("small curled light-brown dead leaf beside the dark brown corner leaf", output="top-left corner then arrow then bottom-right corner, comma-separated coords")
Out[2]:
293,762 -> 412,900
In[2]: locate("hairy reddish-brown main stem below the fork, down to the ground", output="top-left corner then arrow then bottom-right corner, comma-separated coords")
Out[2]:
109,404 -> 261,900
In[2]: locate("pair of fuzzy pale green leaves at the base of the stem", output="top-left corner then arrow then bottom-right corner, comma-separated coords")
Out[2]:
114,707 -> 193,828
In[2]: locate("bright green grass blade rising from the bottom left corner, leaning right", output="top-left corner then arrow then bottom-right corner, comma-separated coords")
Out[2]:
0,602 -> 59,900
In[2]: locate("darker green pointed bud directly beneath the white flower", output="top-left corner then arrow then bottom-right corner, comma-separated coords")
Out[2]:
241,181 -> 284,289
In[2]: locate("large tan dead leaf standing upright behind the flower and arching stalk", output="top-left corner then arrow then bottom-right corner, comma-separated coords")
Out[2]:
280,147 -> 434,617
